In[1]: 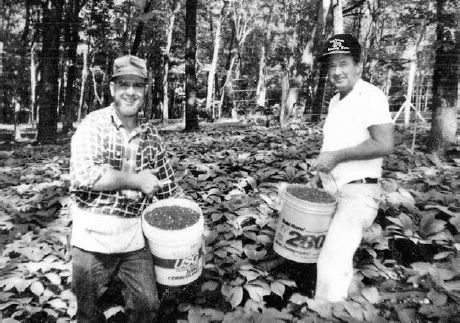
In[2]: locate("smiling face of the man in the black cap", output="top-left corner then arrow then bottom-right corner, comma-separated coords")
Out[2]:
328,54 -> 362,94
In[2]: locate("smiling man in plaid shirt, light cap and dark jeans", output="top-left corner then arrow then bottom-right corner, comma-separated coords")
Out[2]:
70,55 -> 178,322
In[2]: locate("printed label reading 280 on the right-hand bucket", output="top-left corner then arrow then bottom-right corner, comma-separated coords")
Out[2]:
273,219 -> 327,263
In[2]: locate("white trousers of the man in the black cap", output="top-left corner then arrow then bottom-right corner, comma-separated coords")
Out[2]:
315,184 -> 381,302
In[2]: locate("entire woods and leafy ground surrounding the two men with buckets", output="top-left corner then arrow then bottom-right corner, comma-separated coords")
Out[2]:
0,0 -> 460,323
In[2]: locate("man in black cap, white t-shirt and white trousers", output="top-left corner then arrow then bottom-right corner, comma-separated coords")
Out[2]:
314,34 -> 393,302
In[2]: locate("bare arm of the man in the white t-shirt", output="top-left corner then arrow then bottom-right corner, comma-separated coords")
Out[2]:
313,123 -> 394,172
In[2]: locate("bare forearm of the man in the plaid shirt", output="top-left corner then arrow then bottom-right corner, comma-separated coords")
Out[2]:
92,169 -> 139,191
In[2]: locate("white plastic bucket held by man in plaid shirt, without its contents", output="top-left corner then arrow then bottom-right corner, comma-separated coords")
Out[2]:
142,198 -> 204,286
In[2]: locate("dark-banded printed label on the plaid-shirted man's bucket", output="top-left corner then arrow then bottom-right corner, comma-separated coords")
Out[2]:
153,248 -> 203,286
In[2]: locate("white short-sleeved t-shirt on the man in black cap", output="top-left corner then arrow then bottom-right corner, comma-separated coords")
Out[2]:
321,80 -> 392,188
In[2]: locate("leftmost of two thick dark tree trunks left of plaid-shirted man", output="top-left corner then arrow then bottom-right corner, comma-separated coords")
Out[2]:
37,0 -> 63,144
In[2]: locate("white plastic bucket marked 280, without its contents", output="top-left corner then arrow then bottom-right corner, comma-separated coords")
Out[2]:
273,184 -> 337,263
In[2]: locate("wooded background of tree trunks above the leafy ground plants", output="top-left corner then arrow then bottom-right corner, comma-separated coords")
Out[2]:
0,0 -> 459,153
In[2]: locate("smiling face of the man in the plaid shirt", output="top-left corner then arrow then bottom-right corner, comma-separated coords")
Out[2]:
110,75 -> 146,117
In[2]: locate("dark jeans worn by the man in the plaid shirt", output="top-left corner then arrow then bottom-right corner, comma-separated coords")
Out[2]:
72,247 -> 159,323
